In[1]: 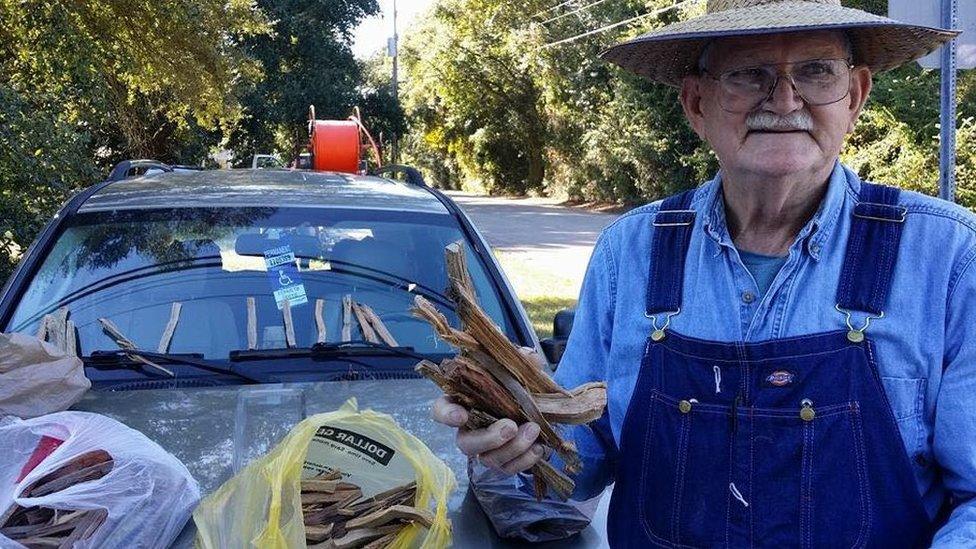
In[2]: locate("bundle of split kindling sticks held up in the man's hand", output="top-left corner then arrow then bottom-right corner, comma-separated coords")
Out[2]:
412,242 -> 607,499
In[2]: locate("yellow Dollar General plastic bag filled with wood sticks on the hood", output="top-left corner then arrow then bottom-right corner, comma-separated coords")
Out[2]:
193,399 -> 455,549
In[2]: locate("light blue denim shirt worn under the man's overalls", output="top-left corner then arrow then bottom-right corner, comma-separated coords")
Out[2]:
473,163 -> 976,546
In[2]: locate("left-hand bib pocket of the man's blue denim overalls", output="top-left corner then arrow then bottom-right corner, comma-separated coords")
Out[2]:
637,391 -> 730,547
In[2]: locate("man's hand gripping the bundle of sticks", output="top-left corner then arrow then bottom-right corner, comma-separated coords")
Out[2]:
432,396 -> 545,475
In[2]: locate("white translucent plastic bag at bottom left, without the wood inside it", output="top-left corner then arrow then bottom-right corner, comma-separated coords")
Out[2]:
0,412 -> 200,549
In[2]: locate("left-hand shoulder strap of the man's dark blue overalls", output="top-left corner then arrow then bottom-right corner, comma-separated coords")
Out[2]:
645,189 -> 695,316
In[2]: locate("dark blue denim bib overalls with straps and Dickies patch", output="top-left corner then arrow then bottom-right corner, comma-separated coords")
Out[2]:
607,183 -> 933,548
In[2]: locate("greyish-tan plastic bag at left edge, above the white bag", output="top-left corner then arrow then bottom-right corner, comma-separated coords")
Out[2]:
0,333 -> 91,418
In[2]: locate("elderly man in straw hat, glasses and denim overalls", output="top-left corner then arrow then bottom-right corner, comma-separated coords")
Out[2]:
434,0 -> 976,547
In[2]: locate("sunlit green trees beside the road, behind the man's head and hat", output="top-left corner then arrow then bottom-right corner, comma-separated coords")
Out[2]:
405,0 -> 976,208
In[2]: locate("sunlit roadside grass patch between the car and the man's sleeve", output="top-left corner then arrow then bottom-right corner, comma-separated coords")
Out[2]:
492,250 -> 579,339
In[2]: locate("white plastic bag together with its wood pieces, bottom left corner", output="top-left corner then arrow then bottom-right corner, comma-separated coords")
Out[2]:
0,412 -> 200,549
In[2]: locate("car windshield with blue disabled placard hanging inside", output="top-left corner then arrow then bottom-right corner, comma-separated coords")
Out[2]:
7,207 -> 515,359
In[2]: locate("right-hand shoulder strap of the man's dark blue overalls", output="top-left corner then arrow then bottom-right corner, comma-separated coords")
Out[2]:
837,183 -> 908,315
